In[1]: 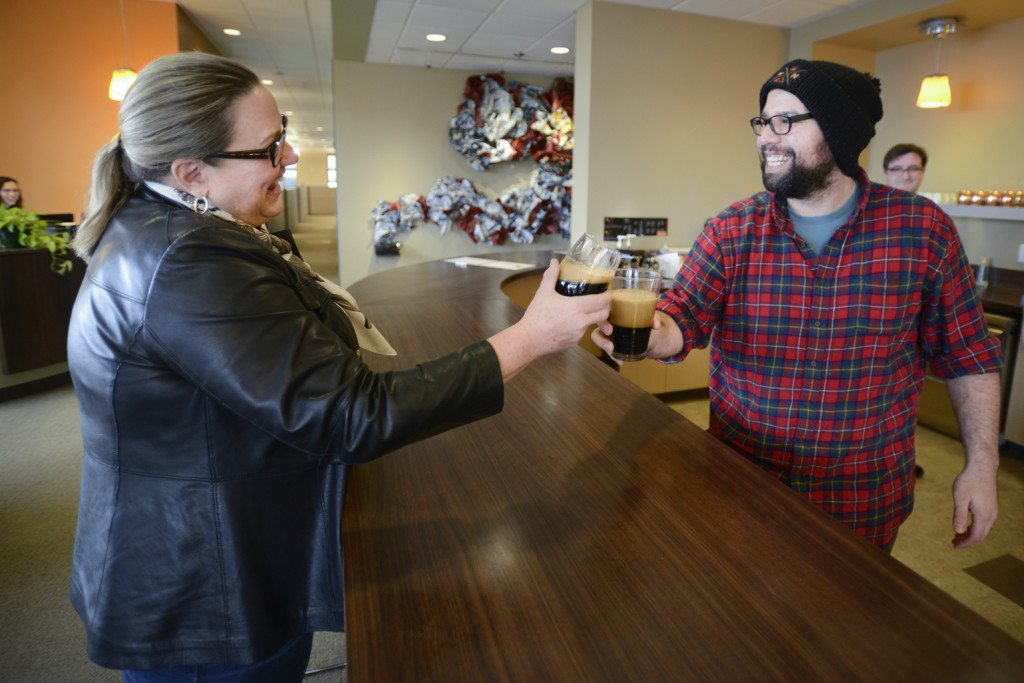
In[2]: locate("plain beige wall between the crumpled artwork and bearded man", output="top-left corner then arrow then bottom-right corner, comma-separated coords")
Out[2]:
572,2 -> 786,248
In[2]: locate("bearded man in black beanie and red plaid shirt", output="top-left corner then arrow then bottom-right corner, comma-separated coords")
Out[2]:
594,59 -> 1001,551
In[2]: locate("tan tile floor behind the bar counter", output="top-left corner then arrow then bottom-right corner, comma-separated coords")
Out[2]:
664,395 -> 1024,642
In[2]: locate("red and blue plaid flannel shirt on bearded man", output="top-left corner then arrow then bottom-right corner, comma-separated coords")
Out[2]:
658,170 -> 1001,545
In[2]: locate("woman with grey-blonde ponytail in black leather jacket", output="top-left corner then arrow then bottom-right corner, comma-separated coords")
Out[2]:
68,52 -> 610,683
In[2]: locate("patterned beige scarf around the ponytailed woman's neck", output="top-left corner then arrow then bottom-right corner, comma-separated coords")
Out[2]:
145,180 -> 397,355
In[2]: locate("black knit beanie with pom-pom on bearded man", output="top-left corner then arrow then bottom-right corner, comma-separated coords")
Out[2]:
761,59 -> 882,177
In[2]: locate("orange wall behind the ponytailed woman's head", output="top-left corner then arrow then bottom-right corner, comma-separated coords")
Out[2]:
0,0 -> 178,218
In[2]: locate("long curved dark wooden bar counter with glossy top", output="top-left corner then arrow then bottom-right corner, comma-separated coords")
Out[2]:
342,253 -> 1024,683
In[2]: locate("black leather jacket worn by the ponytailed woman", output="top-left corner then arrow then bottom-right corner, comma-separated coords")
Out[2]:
68,189 -> 503,669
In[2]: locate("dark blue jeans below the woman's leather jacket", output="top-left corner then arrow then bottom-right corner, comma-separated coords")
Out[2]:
122,633 -> 313,683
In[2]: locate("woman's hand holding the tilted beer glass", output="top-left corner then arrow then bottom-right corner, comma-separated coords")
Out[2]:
487,259 -> 611,379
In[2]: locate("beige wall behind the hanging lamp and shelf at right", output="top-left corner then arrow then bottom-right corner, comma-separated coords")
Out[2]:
867,18 -> 1024,270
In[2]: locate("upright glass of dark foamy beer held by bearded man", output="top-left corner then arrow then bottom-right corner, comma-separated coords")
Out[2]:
608,268 -> 662,360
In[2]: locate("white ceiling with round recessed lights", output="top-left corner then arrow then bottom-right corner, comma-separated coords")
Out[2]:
162,0 -> 869,150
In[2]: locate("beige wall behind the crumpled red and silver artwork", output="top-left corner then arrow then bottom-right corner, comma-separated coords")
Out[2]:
333,60 -> 567,285
